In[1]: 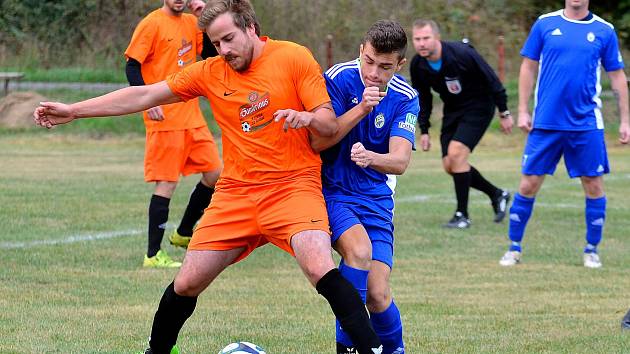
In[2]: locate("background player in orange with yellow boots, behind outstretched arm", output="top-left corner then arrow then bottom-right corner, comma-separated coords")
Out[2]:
125,0 -> 221,267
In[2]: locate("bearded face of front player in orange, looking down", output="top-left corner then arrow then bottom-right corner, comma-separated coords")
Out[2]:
206,13 -> 257,71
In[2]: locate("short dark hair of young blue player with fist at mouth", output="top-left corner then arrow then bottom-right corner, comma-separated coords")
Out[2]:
362,20 -> 407,59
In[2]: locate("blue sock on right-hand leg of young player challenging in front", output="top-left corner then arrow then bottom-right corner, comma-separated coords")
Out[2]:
370,300 -> 405,354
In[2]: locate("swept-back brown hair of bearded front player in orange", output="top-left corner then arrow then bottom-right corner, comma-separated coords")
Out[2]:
198,0 -> 260,36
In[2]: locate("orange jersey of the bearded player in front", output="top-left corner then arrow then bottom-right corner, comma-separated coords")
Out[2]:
166,37 -> 330,185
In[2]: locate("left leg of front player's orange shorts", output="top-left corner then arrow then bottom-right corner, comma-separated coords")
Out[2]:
188,188 -> 267,262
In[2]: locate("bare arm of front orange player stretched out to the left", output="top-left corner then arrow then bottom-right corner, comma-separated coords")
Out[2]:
33,81 -> 181,129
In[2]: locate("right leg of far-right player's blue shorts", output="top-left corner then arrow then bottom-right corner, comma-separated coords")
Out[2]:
564,130 -> 610,178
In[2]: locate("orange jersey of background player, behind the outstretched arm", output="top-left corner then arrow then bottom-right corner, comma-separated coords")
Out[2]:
125,9 -> 206,132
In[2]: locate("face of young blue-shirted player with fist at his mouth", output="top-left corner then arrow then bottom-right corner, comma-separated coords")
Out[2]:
359,42 -> 406,91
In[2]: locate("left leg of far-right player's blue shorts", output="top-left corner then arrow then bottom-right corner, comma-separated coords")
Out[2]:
521,129 -> 566,176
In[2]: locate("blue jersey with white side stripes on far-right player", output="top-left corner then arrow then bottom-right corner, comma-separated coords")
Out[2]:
521,10 -> 624,131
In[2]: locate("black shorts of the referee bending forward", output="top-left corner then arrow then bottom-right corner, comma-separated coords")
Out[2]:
440,105 -> 495,157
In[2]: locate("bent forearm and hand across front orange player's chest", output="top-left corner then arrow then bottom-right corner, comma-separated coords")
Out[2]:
273,102 -> 339,137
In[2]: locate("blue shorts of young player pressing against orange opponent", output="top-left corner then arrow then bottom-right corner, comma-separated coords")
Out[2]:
326,196 -> 394,268
